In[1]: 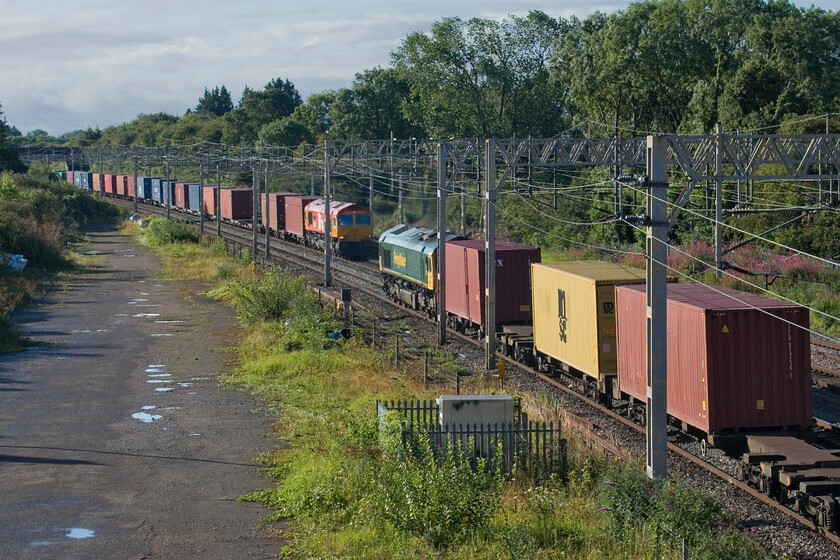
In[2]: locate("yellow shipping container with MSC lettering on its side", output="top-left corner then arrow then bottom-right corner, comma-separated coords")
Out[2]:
531,261 -> 645,388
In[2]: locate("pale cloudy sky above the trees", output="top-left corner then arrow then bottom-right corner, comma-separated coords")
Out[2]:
0,0 -> 840,135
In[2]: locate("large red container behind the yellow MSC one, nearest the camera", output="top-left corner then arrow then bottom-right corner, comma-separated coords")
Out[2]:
615,283 -> 813,434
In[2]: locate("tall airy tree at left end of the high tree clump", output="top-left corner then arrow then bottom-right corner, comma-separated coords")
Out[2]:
392,11 -> 565,137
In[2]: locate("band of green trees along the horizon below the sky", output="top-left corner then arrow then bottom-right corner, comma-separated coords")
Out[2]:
6,0 -> 840,151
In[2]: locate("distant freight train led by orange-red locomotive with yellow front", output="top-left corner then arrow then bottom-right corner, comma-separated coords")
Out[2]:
65,171 -> 373,258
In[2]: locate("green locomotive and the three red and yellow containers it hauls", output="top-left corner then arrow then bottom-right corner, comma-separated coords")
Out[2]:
380,226 -> 813,434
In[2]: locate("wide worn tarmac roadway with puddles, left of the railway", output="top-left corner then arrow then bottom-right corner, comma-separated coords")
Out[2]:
0,228 -> 282,559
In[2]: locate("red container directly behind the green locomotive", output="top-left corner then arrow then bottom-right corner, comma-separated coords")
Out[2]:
446,239 -> 540,325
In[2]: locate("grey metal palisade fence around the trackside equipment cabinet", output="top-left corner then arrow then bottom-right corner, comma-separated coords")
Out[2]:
376,399 -> 566,474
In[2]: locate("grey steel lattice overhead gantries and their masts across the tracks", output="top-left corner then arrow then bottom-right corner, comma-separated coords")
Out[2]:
21,130 -> 840,478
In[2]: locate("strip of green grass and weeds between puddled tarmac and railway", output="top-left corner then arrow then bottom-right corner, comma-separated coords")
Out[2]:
138,230 -> 776,560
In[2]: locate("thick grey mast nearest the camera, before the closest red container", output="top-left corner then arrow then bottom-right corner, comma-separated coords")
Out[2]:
646,135 -> 668,480
